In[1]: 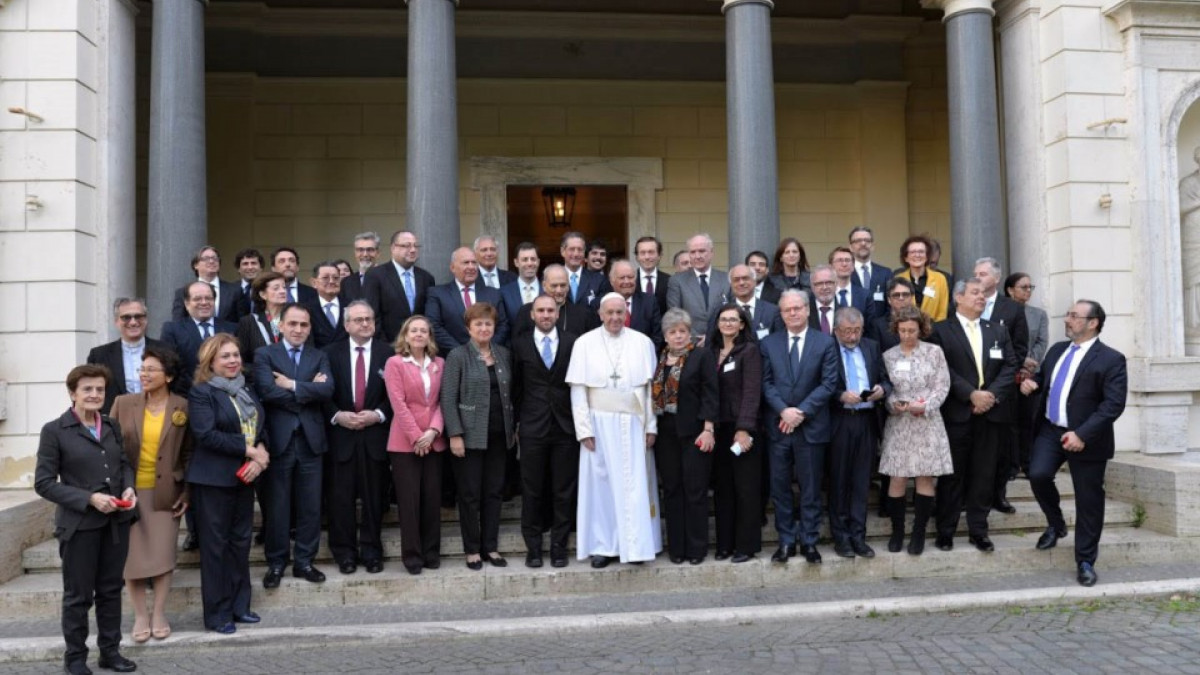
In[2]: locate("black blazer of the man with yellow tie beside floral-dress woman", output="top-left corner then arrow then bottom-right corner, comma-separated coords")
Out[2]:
930,313 -> 1020,424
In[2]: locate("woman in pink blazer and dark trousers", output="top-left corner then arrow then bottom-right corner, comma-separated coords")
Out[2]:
383,315 -> 446,574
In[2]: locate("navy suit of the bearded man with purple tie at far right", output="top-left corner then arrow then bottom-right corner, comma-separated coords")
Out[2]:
1030,340 -> 1129,565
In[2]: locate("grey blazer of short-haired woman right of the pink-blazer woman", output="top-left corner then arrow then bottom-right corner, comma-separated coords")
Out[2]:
442,341 -> 516,449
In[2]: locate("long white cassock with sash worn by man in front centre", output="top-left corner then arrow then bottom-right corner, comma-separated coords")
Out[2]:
566,327 -> 662,562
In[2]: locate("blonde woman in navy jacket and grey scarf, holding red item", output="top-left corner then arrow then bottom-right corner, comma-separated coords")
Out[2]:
186,333 -> 270,634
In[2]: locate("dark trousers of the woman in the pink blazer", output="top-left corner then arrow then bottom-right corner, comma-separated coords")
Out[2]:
388,450 -> 448,567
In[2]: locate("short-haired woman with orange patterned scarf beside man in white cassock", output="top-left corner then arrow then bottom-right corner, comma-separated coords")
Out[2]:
652,307 -> 718,565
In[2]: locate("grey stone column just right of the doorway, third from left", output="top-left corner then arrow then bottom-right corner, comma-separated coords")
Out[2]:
721,0 -> 779,265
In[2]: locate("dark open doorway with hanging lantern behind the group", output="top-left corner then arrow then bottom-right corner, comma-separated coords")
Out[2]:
505,185 -> 629,271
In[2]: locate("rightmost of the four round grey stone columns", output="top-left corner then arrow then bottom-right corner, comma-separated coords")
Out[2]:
920,0 -> 1008,279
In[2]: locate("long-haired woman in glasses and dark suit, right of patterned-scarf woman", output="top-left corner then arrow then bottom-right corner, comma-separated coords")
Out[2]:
704,304 -> 763,562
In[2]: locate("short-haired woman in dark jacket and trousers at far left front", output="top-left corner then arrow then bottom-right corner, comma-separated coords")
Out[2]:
34,365 -> 138,673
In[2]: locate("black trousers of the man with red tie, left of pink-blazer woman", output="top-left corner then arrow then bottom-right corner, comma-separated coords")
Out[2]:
326,448 -> 391,565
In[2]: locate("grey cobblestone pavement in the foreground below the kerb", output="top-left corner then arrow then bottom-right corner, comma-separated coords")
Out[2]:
4,596 -> 1200,675
